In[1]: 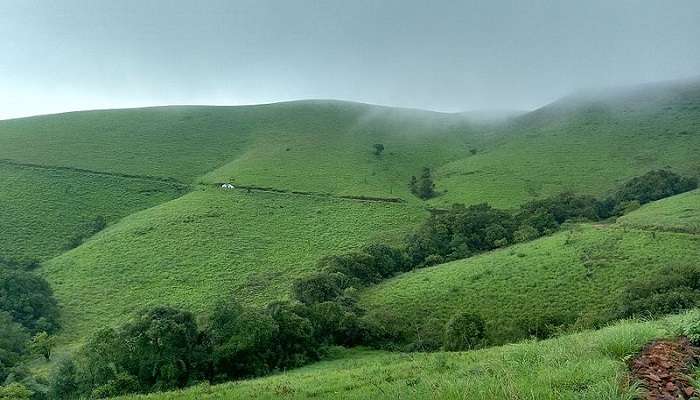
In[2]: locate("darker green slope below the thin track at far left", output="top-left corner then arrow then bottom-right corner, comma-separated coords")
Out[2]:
0,163 -> 184,260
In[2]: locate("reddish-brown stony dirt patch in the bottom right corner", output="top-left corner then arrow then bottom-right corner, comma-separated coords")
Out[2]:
630,338 -> 700,400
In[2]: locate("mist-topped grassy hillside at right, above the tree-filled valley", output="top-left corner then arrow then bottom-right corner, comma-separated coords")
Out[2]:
435,83 -> 700,207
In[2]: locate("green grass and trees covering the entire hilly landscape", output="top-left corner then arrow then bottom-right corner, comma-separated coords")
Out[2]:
0,79 -> 700,399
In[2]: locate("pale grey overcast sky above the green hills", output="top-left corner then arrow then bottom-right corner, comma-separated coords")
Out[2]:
0,0 -> 700,119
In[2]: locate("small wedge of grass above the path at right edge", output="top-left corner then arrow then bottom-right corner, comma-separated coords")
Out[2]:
618,189 -> 700,234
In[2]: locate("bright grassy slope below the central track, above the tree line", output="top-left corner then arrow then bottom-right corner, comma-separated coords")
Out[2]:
43,189 -> 425,338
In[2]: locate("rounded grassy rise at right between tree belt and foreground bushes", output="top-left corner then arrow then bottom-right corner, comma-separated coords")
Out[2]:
362,225 -> 700,344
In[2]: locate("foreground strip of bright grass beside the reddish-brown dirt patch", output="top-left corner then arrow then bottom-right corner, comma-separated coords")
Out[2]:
119,317 -> 678,400
